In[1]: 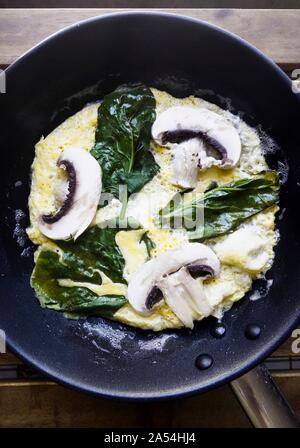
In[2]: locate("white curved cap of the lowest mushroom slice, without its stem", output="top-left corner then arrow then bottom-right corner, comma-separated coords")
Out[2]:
127,243 -> 220,314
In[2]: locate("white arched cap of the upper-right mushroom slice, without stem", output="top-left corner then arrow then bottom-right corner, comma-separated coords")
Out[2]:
152,106 -> 241,169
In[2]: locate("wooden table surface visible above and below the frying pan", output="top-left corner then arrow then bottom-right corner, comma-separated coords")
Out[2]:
0,9 -> 300,428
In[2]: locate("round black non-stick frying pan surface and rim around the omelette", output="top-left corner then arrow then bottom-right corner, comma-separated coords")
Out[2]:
0,12 -> 300,426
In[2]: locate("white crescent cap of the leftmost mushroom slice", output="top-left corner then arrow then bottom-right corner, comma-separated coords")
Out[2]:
39,147 -> 102,240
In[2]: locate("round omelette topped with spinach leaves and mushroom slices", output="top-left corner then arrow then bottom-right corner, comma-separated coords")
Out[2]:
27,88 -> 279,331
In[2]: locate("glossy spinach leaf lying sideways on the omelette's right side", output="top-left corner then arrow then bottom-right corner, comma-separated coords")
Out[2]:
159,171 -> 279,241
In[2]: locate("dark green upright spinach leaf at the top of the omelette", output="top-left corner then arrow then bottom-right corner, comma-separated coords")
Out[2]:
91,85 -> 159,196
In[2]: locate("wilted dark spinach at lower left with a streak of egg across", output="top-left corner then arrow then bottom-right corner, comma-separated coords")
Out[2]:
31,227 -> 127,317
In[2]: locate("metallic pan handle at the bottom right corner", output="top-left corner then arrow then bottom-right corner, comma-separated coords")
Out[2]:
231,364 -> 300,428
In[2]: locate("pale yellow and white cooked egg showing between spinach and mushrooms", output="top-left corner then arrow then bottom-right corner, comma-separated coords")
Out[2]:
27,89 -> 278,331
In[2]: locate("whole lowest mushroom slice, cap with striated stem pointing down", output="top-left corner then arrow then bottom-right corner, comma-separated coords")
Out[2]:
127,243 -> 220,327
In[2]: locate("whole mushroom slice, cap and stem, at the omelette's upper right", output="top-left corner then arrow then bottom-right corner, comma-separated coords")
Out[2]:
152,106 -> 241,188
